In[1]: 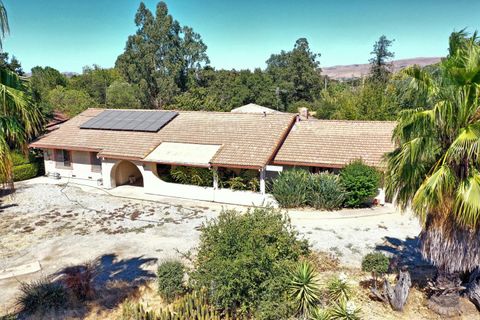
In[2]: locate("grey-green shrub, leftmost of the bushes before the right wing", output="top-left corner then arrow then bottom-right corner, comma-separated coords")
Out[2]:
271,169 -> 310,208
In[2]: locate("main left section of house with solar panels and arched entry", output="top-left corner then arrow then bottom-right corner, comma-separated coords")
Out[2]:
30,109 -> 295,205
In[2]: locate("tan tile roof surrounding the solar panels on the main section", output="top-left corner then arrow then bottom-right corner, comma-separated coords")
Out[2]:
31,109 -> 295,168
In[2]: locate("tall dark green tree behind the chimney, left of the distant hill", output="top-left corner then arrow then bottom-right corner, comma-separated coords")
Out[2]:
266,38 -> 322,110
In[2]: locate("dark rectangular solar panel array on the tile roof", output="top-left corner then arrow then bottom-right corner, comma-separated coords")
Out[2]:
80,110 -> 178,132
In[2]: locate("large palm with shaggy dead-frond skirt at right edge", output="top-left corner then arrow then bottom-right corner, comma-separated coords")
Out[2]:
386,30 -> 480,310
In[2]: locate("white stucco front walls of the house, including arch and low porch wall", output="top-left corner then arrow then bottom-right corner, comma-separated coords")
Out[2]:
45,151 -> 276,206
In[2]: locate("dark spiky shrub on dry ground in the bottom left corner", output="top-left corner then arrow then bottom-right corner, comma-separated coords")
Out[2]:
17,278 -> 68,314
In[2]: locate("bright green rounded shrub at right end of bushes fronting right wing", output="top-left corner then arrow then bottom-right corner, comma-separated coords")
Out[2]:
340,161 -> 380,207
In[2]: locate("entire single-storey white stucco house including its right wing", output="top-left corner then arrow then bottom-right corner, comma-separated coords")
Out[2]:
30,109 -> 394,205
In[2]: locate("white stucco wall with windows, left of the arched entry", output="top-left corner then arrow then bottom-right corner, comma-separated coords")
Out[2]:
44,151 -> 102,186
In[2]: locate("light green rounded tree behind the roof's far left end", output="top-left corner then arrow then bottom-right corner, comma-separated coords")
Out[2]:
47,86 -> 98,117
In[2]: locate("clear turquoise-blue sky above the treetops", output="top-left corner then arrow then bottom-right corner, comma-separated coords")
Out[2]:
3,0 -> 480,72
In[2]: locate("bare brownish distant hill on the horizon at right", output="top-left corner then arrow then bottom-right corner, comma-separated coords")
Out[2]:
322,57 -> 441,80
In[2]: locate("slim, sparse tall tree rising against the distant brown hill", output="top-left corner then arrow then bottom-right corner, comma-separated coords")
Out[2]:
369,35 -> 395,82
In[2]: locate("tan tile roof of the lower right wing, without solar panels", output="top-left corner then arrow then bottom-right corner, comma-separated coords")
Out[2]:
274,119 -> 395,168
